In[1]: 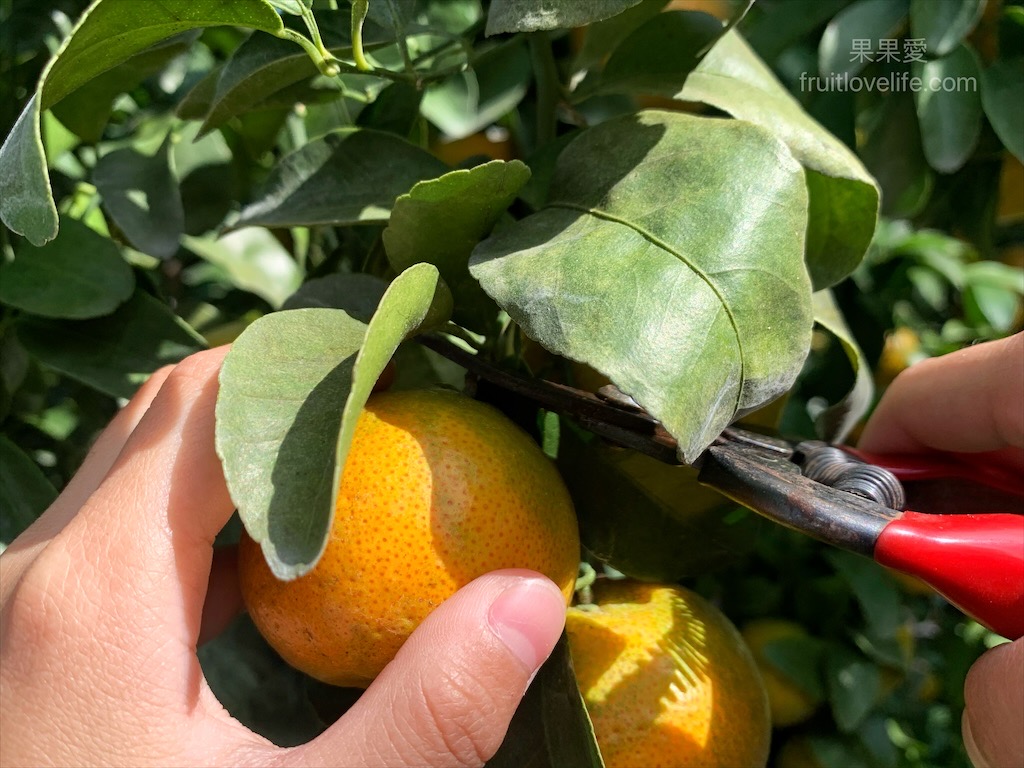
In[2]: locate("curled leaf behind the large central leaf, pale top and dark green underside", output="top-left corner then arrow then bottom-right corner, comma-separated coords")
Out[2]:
676,31 -> 879,290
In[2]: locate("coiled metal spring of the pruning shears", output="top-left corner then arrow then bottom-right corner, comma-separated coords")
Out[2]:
797,440 -> 906,510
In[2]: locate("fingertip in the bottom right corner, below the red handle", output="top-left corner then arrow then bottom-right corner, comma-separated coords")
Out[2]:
963,639 -> 1024,768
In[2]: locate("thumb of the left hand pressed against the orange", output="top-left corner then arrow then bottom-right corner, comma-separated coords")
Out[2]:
290,570 -> 565,768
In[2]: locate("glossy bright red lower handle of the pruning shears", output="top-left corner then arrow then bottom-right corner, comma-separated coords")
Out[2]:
874,512 -> 1024,640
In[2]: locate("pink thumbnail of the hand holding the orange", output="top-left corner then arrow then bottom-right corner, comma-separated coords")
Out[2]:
487,579 -> 565,670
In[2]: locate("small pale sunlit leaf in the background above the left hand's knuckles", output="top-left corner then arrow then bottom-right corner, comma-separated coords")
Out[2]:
183,227 -> 302,309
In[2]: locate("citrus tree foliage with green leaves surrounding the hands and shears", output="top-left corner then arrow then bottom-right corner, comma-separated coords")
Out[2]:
0,0 -> 1024,767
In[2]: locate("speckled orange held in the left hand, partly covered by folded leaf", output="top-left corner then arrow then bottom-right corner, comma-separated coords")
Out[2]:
239,390 -> 580,687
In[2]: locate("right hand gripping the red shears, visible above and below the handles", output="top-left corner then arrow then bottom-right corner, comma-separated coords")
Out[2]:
860,334 -> 1024,768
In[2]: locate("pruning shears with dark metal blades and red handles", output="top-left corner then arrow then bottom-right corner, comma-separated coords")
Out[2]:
421,337 -> 1024,639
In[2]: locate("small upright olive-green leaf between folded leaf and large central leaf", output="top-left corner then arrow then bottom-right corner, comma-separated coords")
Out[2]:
383,160 -> 529,331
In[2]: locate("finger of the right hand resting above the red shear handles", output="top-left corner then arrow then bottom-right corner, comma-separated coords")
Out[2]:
859,333 -> 1024,467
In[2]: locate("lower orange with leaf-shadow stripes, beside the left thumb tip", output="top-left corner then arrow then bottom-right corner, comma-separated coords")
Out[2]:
565,581 -> 771,768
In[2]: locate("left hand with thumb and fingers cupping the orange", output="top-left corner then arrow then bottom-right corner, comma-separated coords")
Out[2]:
0,348 -> 565,768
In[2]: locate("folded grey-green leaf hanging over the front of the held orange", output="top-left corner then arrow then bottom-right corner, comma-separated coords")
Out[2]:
216,264 -> 442,579
